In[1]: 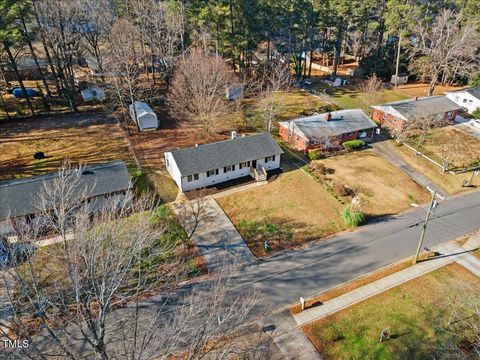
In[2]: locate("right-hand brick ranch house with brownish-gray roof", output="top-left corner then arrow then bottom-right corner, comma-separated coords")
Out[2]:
372,95 -> 462,130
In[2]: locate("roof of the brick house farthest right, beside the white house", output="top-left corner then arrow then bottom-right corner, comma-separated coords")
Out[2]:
381,95 -> 462,120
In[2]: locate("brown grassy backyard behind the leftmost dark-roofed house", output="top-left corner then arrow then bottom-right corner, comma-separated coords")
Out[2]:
0,113 -> 133,179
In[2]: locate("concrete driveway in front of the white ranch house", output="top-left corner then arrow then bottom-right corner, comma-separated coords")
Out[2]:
173,196 -> 257,272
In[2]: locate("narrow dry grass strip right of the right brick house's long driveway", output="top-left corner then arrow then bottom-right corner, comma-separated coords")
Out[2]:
392,145 -> 474,195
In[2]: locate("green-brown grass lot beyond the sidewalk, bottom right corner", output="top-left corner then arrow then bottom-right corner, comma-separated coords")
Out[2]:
304,264 -> 480,359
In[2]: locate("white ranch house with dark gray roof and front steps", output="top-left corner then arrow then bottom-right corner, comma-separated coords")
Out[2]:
164,132 -> 283,192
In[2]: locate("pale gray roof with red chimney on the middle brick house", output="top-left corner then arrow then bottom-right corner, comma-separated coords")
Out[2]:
280,109 -> 377,140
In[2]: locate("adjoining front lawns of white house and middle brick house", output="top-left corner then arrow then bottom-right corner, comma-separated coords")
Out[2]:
217,150 -> 429,256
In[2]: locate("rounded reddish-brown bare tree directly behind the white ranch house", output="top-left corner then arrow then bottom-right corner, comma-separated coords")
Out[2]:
167,49 -> 236,141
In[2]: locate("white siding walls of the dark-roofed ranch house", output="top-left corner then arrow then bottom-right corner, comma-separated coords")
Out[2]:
179,154 -> 280,191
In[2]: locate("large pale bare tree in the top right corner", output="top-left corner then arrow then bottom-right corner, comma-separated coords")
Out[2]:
410,10 -> 480,96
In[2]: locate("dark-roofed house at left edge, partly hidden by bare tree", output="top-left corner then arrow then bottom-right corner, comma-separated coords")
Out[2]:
0,160 -> 130,235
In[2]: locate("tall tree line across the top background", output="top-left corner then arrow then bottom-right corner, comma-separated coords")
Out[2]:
0,0 -> 480,119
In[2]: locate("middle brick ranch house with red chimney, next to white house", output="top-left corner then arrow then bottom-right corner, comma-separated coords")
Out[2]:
278,109 -> 377,152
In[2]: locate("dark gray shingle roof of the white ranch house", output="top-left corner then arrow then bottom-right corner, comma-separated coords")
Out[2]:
171,133 -> 283,176
